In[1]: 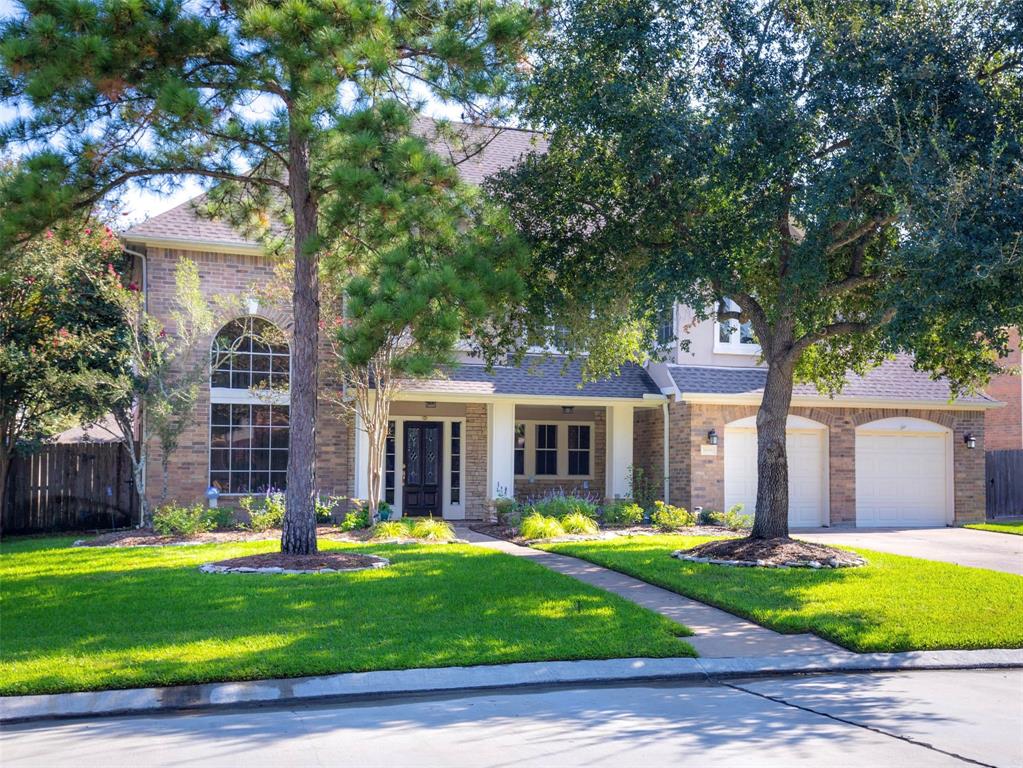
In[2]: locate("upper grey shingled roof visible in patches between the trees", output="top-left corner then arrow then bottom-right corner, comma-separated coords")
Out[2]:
122,118 -> 547,249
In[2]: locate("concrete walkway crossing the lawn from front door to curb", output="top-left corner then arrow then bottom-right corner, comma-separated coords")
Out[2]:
458,528 -> 849,659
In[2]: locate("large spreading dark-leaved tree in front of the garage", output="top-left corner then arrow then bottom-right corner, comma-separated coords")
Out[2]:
493,0 -> 1023,539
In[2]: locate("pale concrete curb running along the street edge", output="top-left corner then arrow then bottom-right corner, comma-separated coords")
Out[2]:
0,649 -> 1023,723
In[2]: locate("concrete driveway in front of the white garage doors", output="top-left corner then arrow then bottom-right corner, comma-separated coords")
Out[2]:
793,528 -> 1023,576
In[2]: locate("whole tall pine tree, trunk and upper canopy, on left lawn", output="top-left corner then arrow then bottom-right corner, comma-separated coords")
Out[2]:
0,0 -> 538,553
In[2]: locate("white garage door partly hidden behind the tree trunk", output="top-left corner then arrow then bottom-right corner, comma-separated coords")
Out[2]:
724,426 -> 827,528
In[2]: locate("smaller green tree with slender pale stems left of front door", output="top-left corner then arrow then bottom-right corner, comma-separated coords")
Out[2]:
322,101 -> 527,516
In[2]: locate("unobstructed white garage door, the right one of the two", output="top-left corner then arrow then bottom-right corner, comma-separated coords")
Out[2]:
856,422 -> 949,528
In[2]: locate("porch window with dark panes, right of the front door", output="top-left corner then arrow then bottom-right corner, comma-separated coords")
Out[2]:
515,421 -> 595,479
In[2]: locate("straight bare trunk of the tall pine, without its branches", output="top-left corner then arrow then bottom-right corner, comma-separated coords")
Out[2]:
280,131 -> 319,554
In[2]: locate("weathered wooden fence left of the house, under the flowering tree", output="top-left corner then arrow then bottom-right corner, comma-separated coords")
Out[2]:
0,443 -> 138,535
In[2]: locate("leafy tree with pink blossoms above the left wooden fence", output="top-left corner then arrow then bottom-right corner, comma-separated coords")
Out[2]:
0,221 -> 131,518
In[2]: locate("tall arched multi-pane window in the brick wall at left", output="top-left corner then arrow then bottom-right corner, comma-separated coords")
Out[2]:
210,318 -> 291,494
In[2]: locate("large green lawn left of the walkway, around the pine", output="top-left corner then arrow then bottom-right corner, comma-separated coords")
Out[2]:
0,538 -> 696,695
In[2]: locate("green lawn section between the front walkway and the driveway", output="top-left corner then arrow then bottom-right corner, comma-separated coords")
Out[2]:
542,536 -> 1023,652
